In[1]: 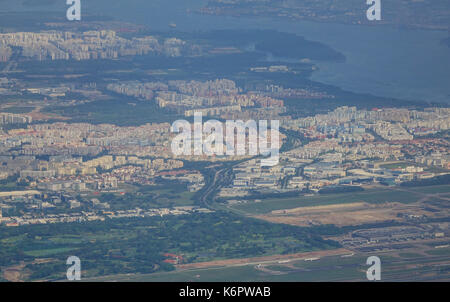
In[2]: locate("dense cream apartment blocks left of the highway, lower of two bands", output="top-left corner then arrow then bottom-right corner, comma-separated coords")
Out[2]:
15,155 -> 184,192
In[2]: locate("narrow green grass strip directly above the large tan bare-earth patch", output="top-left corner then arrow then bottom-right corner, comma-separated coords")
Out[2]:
230,189 -> 420,215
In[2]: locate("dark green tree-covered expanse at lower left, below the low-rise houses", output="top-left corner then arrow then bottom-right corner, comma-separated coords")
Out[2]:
0,212 -> 340,281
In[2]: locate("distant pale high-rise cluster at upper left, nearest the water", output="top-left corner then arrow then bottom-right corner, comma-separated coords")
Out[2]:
0,30 -> 192,62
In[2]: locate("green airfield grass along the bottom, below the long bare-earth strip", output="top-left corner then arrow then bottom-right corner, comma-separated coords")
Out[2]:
89,253 -> 448,282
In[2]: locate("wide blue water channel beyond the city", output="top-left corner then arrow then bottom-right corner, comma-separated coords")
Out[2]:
0,0 -> 450,103
